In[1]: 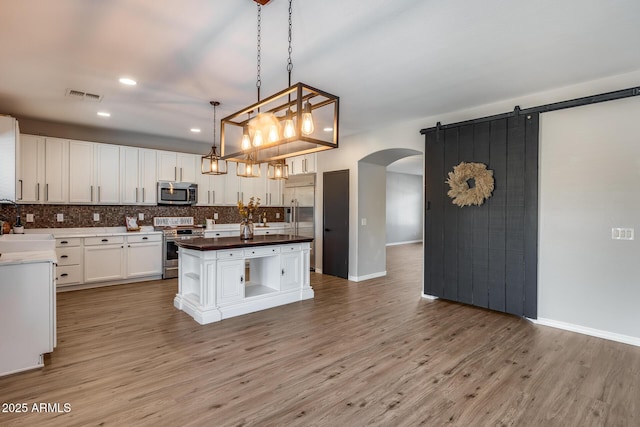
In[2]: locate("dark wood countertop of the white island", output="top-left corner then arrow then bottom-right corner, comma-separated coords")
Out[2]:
176,234 -> 313,251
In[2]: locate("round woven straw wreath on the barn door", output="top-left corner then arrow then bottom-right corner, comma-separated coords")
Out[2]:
445,162 -> 493,207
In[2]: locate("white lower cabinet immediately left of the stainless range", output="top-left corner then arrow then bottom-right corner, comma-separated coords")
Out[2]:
125,234 -> 162,279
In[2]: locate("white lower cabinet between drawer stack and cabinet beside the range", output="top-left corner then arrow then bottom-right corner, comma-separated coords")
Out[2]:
84,236 -> 125,283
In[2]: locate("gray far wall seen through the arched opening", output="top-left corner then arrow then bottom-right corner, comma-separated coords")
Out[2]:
386,172 -> 424,245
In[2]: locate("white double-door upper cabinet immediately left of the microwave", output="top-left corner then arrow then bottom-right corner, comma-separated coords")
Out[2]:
120,147 -> 158,205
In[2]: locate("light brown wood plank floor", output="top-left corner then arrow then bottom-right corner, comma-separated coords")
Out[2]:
0,244 -> 640,427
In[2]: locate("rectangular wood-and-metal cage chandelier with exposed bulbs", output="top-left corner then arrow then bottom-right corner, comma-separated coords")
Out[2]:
220,83 -> 340,163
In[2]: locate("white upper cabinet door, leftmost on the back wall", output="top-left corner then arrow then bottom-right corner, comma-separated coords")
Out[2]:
16,135 -> 44,203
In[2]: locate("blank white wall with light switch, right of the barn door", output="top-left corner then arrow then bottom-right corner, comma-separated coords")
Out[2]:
538,97 -> 640,345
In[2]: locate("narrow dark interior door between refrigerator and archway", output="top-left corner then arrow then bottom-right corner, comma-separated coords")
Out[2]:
322,170 -> 349,279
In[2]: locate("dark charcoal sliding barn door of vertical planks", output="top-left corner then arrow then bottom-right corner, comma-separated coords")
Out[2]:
424,112 -> 539,318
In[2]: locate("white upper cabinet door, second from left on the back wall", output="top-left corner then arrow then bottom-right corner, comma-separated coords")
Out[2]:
44,138 -> 69,203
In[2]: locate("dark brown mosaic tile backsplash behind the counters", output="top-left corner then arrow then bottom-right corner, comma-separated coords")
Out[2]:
0,205 -> 284,229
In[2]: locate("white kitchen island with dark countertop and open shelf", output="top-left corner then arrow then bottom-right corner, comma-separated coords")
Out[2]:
174,234 -> 313,325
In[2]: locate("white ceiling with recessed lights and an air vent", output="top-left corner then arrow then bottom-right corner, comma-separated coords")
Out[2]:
0,0 -> 640,151
